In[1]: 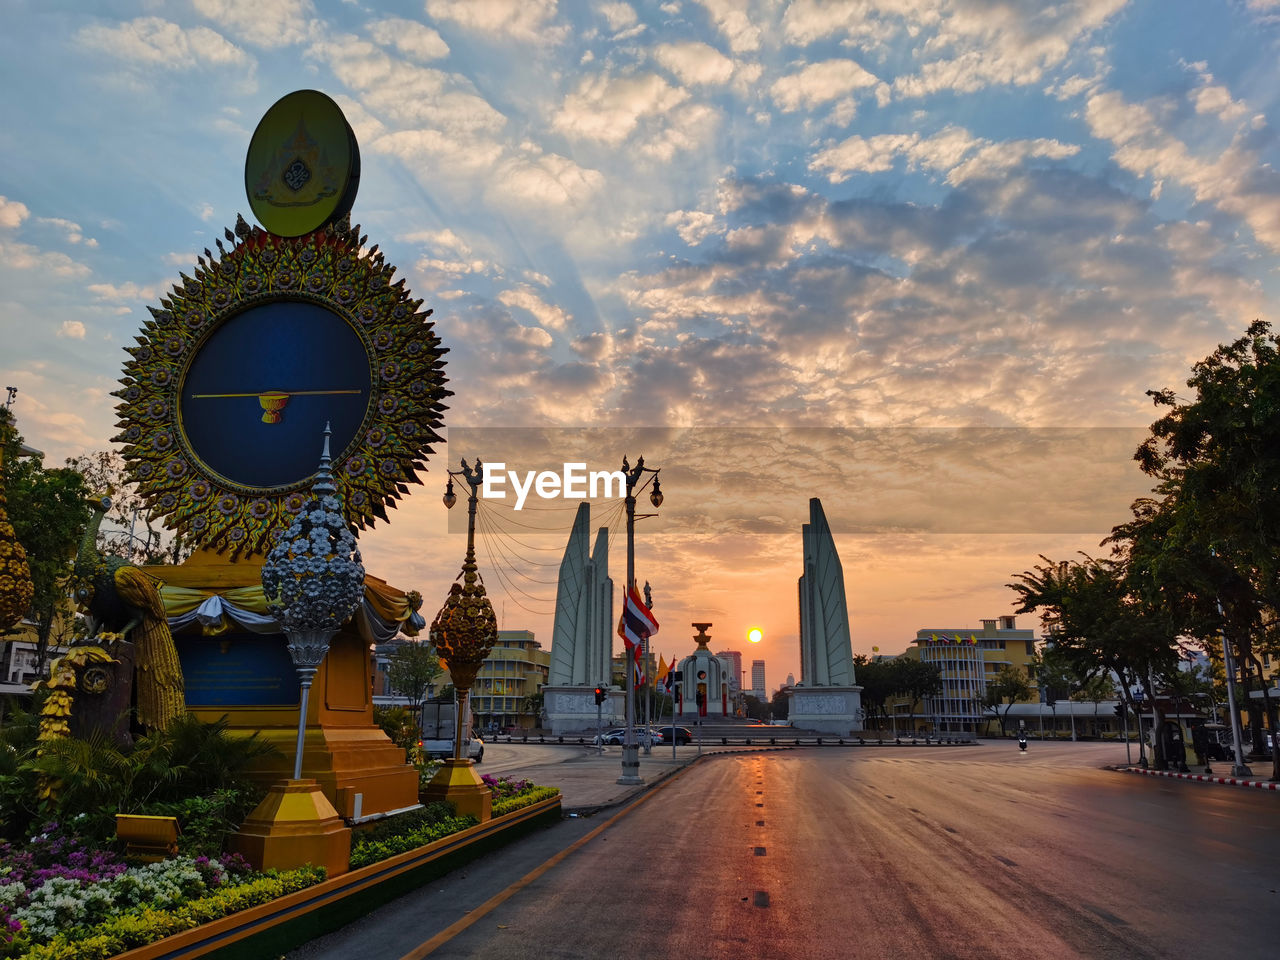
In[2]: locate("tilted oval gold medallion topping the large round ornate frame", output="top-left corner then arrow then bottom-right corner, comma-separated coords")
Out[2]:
244,90 -> 360,237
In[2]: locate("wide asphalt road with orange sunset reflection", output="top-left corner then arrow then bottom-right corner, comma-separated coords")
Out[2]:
292,741 -> 1280,960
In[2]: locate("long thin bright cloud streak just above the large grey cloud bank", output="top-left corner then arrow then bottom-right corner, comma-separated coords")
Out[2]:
809,127 -> 1080,184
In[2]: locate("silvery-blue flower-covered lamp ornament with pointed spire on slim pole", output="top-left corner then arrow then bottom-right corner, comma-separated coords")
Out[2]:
262,424 -> 365,780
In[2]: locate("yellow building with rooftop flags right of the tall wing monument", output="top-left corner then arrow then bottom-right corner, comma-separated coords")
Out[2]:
888,617 -> 1036,733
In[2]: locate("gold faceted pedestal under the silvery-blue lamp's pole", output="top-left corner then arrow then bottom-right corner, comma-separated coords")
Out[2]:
227,780 -> 351,877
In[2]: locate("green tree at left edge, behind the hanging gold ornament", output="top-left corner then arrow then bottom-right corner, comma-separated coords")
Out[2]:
0,408 -> 90,673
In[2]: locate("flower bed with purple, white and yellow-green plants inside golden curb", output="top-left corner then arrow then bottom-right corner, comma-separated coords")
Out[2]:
0,778 -> 561,960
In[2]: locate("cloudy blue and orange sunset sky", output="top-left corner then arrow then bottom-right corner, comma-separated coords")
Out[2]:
0,0 -> 1280,689
